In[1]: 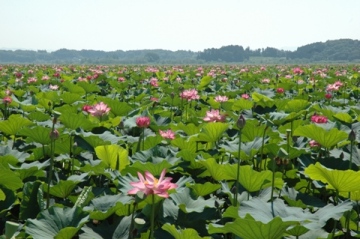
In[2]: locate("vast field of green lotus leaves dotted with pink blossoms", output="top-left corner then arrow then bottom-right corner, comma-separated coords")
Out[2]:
0,65 -> 360,239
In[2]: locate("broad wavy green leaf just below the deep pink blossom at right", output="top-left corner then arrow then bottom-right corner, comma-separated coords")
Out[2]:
293,124 -> 348,149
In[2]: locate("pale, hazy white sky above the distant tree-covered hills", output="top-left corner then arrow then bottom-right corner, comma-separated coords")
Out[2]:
0,0 -> 360,52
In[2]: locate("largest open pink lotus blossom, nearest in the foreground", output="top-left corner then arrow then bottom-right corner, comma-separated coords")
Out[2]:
128,169 -> 178,198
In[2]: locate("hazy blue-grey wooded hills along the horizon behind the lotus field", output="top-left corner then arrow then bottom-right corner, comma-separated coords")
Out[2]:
0,39 -> 360,64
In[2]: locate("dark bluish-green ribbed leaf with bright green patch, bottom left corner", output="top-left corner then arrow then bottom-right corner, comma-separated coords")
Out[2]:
25,207 -> 89,239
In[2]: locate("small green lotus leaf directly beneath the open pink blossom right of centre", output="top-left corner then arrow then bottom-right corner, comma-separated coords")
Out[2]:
197,122 -> 229,142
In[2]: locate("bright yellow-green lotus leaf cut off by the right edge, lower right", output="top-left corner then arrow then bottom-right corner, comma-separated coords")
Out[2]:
304,163 -> 360,192
